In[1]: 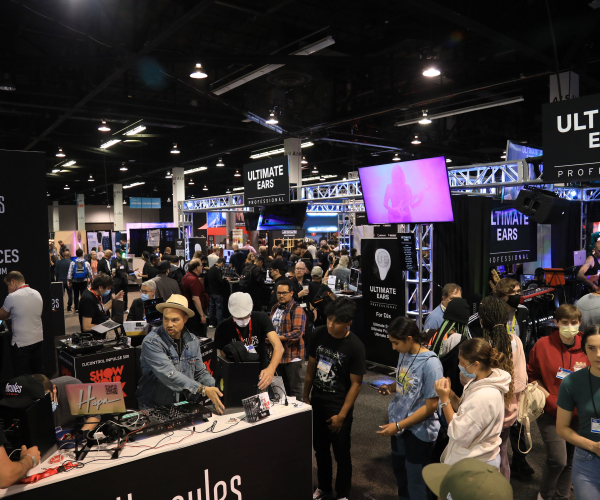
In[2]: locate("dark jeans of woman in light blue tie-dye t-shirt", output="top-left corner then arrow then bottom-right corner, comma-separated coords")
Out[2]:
392,431 -> 435,500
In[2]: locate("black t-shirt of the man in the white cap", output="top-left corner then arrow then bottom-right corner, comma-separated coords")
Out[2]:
215,311 -> 275,368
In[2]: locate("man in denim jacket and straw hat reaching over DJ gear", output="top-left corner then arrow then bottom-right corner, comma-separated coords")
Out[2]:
137,294 -> 225,413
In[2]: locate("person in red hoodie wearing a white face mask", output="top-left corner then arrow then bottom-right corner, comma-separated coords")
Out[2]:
527,304 -> 589,500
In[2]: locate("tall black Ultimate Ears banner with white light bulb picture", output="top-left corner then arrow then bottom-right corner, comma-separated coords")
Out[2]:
355,238 -> 405,367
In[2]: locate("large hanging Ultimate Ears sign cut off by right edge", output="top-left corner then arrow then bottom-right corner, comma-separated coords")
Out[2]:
542,94 -> 600,183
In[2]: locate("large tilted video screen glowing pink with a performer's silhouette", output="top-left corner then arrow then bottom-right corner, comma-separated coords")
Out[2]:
358,156 -> 454,224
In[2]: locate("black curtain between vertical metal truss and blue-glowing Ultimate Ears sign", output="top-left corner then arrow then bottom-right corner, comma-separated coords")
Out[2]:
433,195 -> 492,310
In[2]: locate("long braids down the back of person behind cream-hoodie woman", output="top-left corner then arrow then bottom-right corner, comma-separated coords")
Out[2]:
479,295 -> 515,404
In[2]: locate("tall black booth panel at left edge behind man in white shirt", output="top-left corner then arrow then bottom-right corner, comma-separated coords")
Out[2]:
0,150 -> 56,374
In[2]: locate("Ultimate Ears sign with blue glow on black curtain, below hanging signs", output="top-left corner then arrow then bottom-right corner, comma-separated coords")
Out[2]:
490,205 -> 537,266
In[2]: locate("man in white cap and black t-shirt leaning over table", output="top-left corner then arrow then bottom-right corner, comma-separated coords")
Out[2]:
215,292 -> 283,390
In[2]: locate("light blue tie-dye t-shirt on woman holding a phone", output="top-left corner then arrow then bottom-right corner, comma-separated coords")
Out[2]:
388,350 -> 444,442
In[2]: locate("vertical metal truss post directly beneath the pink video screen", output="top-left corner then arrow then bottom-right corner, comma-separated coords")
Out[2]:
404,224 -> 433,328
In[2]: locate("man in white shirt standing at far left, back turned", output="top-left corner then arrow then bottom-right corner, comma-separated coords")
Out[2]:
0,271 -> 44,375
